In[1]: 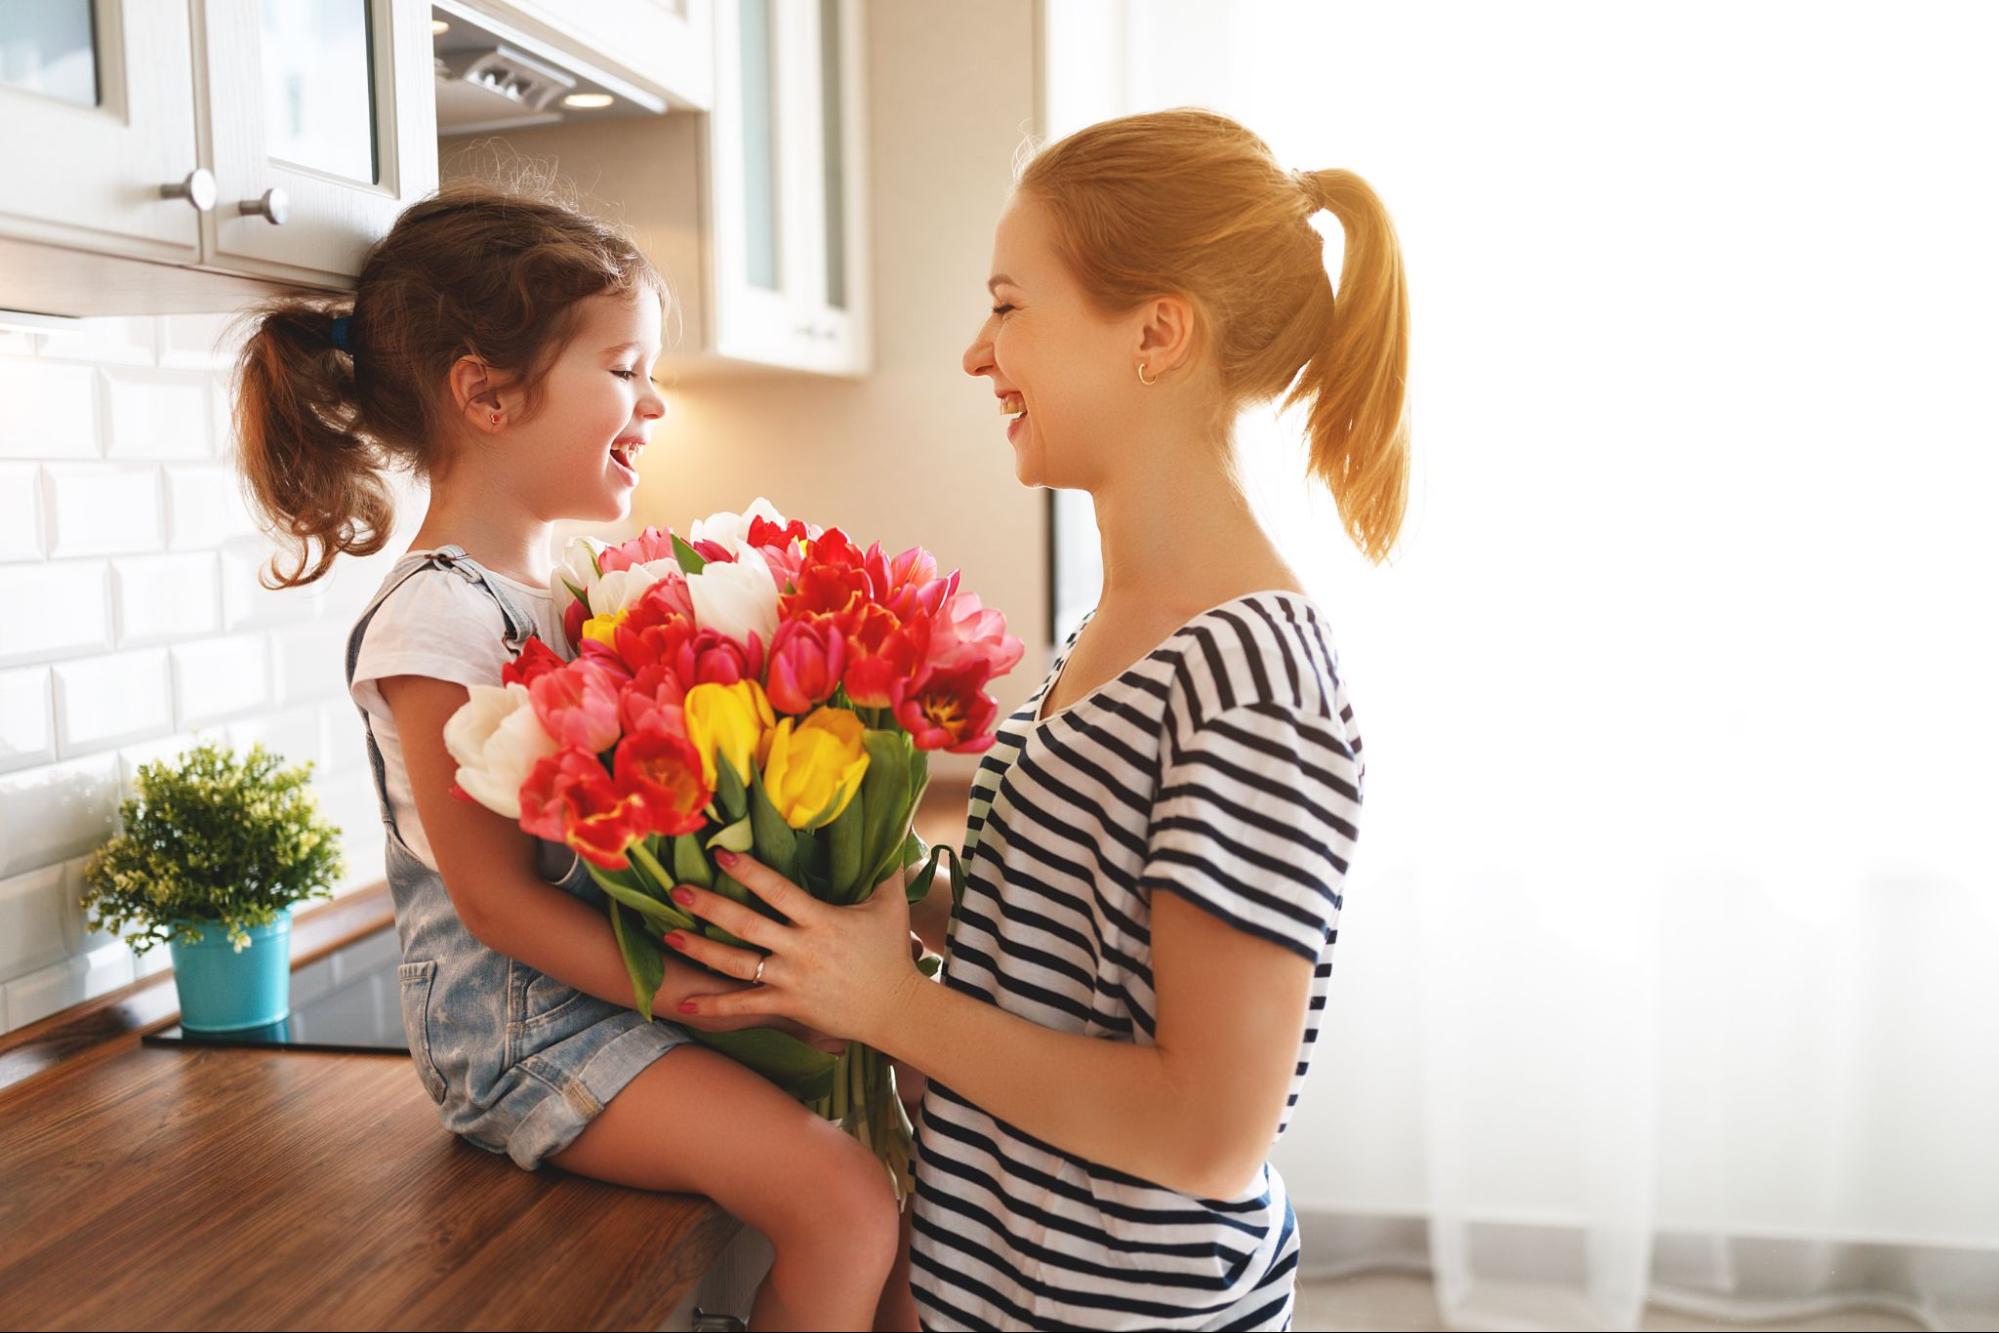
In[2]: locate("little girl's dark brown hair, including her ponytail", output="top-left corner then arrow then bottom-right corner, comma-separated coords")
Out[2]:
236,180 -> 666,588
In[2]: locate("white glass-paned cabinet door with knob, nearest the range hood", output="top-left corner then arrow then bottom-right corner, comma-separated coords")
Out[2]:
200,0 -> 438,288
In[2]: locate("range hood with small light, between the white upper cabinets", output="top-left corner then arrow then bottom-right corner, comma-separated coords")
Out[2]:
430,2 -> 666,138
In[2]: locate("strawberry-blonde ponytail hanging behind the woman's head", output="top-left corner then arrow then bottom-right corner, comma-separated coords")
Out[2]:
1285,170 -> 1409,562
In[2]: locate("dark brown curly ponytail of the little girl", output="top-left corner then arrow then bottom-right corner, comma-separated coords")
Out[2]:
236,305 -> 394,588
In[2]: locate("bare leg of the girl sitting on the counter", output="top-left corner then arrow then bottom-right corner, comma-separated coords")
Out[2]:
550,1045 -> 898,1329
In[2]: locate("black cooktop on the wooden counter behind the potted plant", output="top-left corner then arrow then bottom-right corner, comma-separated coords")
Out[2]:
146,927 -> 410,1053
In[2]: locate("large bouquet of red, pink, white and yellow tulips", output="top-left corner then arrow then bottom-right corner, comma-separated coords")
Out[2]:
444,500 -> 1021,1197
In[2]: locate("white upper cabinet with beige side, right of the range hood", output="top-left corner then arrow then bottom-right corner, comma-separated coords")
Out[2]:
463,0 -> 874,378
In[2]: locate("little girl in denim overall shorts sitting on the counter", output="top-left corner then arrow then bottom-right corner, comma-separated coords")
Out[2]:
238,188 -> 908,1329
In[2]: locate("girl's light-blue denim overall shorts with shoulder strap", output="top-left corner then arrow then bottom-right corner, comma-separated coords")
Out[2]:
348,546 -> 692,1171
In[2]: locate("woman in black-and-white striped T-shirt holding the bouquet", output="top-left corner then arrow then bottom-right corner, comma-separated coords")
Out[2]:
672,112 -> 1407,1329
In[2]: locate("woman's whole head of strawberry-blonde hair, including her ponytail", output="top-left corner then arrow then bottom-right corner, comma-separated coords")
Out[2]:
1017,110 -> 1409,562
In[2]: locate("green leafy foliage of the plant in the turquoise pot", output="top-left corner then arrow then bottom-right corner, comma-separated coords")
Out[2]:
82,743 -> 342,953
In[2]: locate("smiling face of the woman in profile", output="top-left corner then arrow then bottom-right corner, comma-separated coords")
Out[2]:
964,194 -> 1137,490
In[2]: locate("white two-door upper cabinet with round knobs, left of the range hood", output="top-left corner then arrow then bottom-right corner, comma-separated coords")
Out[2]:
0,0 -> 436,314
